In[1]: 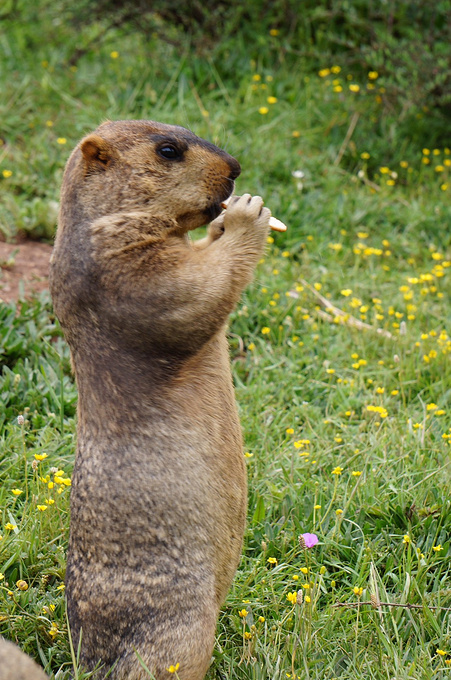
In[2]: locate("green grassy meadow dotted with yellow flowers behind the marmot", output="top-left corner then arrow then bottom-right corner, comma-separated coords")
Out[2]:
0,0 -> 451,680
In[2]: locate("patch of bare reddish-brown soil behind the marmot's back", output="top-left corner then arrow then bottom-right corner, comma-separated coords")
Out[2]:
0,241 -> 52,302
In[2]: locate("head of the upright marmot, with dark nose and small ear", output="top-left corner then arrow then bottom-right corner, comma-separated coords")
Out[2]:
62,120 -> 241,231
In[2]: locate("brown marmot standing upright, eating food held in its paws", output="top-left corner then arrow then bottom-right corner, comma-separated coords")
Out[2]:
50,121 -> 270,680
